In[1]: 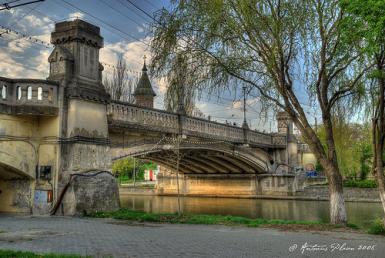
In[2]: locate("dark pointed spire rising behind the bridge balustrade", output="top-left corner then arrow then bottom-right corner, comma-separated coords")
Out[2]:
134,61 -> 156,108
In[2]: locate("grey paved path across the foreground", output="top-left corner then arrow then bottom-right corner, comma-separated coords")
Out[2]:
0,215 -> 385,258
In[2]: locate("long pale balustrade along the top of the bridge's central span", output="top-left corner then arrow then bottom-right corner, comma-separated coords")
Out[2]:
107,101 -> 286,147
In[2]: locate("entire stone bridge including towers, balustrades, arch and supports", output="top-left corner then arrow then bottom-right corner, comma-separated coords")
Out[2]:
0,19 -> 312,214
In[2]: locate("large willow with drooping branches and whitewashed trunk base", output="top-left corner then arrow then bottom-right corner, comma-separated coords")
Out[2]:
152,0 -> 362,223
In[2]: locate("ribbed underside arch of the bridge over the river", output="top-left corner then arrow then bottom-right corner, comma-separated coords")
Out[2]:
111,143 -> 273,174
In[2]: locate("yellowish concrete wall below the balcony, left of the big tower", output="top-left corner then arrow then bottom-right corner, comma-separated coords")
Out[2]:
0,111 -> 59,213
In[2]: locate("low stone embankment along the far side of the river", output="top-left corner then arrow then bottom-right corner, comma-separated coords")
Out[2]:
119,185 -> 381,203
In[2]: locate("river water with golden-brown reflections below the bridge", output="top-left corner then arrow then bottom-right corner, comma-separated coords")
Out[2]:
120,194 -> 383,225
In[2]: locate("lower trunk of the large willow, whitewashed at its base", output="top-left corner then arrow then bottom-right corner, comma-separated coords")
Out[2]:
321,160 -> 347,225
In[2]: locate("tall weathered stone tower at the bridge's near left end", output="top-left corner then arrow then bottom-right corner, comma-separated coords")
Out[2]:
48,19 -> 119,214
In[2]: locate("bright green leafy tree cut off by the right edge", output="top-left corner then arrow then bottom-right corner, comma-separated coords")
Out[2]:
342,0 -> 385,225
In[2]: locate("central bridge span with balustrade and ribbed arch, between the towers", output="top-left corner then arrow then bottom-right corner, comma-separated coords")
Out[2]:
107,102 -> 286,174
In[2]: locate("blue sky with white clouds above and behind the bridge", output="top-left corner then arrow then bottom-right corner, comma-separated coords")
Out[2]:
0,0 -> 318,132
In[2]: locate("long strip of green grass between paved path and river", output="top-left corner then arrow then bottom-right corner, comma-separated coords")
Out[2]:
88,209 -> 358,229
